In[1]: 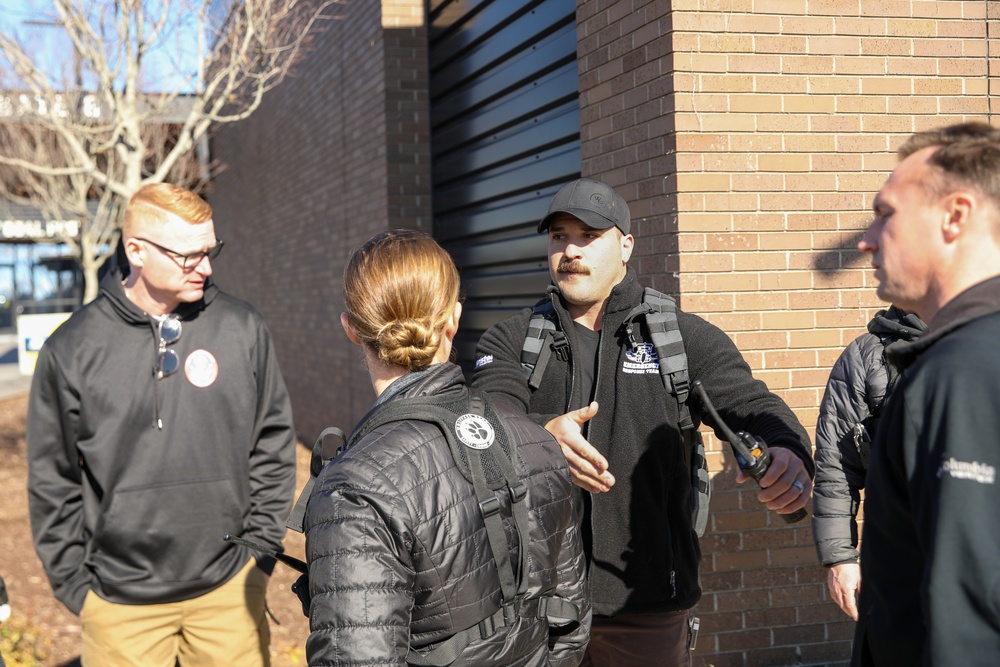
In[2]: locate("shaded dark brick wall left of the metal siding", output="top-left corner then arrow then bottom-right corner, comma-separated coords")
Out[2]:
209,0 -> 430,444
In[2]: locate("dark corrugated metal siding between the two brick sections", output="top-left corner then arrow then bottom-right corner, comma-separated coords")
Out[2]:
429,0 -> 580,367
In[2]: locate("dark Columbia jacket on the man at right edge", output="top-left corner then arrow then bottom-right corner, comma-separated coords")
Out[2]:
853,277 -> 1000,667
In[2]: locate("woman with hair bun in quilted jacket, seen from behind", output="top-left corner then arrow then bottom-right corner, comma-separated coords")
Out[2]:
305,231 -> 590,666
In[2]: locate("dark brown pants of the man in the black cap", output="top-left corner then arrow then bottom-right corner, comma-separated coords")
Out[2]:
580,610 -> 691,667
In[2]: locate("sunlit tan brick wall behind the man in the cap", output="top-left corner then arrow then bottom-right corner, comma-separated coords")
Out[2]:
577,0 -> 1000,667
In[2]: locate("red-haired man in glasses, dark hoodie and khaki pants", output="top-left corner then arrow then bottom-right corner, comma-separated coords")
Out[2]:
28,183 -> 295,667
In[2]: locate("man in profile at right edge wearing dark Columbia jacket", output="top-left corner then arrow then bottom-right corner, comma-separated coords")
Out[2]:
853,123 -> 1000,667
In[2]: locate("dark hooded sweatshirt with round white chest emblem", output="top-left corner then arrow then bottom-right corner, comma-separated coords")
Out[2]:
28,271 -> 295,613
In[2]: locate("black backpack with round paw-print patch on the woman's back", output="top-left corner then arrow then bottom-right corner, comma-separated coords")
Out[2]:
286,387 -> 581,667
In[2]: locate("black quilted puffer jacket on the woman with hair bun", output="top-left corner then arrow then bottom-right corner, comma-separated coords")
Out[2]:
305,363 -> 590,666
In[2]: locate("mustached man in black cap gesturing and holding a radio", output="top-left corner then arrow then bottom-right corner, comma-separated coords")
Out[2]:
473,179 -> 813,667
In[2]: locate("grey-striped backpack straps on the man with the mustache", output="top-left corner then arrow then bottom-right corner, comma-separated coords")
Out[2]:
521,287 -> 712,537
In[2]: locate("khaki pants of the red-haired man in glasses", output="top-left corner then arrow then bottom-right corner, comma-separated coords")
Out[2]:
80,558 -> 271,667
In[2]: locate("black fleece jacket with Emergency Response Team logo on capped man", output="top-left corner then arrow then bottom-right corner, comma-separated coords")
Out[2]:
472,269 -> 812,615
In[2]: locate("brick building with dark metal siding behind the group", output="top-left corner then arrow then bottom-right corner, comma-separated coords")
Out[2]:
211,0 -> 1000,667
